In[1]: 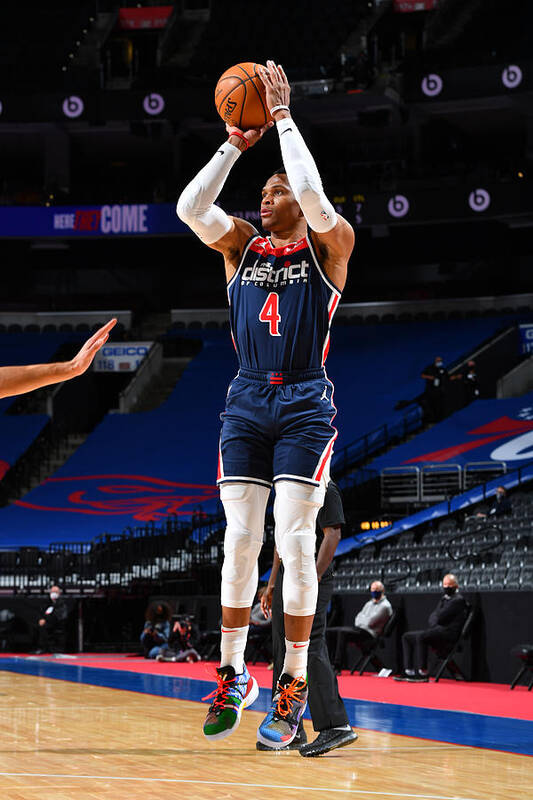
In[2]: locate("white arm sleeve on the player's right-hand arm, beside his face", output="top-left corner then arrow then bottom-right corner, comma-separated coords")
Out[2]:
276,117 -> 337,233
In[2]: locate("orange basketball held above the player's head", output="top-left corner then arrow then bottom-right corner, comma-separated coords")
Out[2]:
215,61 -> 272,130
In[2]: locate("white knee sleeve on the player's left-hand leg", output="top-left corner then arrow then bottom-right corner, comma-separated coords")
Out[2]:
220,483 -> 270,608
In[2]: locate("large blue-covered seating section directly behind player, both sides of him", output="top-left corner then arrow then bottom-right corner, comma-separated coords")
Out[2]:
0,316 -> 515,546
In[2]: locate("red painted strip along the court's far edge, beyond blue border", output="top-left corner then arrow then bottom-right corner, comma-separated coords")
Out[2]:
5,653 -> 533,721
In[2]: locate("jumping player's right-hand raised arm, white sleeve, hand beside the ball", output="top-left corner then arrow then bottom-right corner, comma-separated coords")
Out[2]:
260,61 -> 354,282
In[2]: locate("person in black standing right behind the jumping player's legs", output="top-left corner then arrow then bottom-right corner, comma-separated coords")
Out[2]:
256,481 -> 357,757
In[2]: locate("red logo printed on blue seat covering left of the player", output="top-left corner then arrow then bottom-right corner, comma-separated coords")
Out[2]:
15,475 -> 218,523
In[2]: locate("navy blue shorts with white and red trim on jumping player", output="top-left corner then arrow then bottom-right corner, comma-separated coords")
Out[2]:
217,369 -> 337,486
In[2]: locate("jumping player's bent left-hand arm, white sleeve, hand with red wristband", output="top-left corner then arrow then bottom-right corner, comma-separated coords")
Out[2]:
176,122 -> 274,276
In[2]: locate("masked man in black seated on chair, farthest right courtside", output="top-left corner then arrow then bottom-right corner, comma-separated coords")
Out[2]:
395,575 -> 466,683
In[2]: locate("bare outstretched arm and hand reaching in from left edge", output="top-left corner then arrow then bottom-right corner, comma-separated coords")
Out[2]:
0,319 -> 117,398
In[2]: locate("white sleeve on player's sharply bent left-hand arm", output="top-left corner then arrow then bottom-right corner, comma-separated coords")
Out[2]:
176,142 -> 241,244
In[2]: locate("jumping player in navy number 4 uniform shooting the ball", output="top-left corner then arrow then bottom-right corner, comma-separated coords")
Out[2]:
177,61 -> 354,749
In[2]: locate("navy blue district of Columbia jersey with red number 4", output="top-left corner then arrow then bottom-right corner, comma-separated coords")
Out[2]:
228,234 -> 341,372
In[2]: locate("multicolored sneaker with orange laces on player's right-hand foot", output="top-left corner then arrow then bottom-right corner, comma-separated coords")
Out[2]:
257,673 -> 307,750
